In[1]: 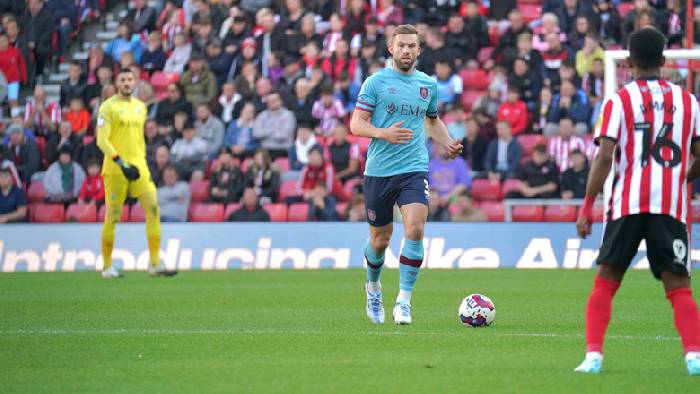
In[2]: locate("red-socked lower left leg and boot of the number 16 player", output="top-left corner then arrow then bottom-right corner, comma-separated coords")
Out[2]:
574,265 -> 622,374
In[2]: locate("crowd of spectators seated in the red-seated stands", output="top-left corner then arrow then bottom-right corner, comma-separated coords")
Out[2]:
0,0 -> 700,222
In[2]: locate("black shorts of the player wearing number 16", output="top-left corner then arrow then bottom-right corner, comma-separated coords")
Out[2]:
597,213 -> 690,279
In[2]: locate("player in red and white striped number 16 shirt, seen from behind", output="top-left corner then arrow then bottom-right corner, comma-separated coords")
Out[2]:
576,27 -> 700,375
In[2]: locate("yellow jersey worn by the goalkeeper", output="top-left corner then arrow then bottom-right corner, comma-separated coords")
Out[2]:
97,95 -> 148,175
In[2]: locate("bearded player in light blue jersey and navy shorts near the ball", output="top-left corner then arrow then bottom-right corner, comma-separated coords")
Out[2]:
350,25 -> 462,324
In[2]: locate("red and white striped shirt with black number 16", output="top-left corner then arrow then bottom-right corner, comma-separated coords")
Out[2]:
596,80 -> 700,223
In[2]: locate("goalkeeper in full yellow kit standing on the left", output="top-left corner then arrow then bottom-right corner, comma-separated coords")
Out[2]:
97,68 -> 177,278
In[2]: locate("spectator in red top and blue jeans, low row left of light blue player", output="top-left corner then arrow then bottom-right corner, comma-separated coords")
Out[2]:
299,147 -> 338,222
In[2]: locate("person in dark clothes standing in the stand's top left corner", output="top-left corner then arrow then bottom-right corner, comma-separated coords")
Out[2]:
19,0 -> 54,76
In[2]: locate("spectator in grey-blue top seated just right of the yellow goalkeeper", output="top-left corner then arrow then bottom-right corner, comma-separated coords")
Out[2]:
158,166 -> 190,222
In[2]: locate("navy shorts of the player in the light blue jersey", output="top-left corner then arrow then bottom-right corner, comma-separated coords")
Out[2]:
364,172 -> 430,227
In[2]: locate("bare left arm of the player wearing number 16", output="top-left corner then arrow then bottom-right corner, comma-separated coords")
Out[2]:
576,137 -> 617,239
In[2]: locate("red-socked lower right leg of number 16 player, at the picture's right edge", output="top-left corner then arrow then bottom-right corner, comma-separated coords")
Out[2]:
662,272 -> 700,376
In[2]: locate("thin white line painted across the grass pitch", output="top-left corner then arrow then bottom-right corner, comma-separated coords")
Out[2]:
0,328 -> 679,341
